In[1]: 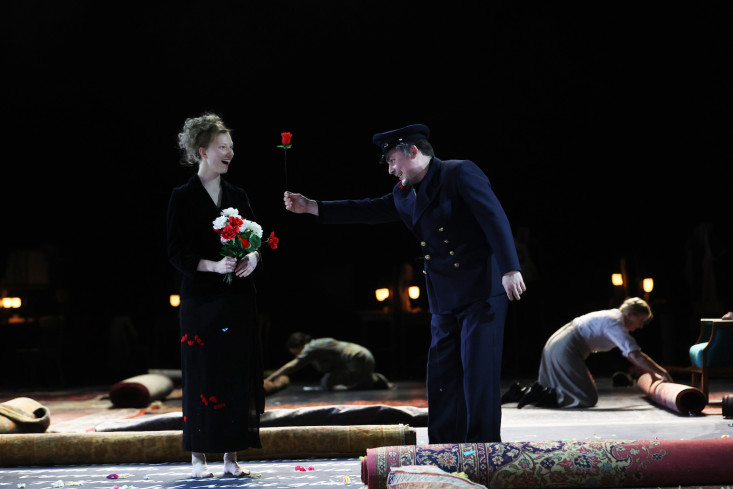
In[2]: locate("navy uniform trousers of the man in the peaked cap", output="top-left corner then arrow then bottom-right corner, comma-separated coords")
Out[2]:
427,294 -> 508,444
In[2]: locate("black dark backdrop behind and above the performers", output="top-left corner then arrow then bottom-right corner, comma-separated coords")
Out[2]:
0,1 -> 733,387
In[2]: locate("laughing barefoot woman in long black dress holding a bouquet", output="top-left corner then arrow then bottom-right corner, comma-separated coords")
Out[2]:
167,114 -> 265,477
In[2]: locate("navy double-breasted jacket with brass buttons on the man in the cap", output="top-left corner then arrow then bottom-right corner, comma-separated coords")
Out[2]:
318,157 -> 520,314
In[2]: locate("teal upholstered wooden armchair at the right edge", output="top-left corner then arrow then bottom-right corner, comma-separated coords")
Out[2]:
690,318 -> 733,396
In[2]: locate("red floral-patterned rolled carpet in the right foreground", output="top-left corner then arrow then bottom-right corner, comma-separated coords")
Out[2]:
361,438 -> 733,489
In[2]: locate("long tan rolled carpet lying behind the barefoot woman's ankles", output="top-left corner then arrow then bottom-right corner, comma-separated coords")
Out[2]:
0,425 -> 417,467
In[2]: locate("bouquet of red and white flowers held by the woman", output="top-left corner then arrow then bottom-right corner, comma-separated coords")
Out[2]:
213,207 -> 280,284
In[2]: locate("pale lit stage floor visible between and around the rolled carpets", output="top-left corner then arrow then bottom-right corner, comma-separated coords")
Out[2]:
0,378 -> 733,489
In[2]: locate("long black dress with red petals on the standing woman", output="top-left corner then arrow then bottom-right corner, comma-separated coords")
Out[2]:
167,175 -> 265,453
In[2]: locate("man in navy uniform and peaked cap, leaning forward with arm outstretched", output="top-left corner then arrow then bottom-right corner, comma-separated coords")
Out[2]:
284,124 -> 526,443
